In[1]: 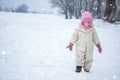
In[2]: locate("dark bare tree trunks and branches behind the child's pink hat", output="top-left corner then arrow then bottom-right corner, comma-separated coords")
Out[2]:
51,0 -> 120,23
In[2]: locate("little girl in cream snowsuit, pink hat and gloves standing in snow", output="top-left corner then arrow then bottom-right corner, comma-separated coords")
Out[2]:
67,10 -> 102,72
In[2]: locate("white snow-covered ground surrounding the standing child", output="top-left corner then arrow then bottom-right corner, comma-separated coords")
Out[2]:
0,12 -> 120,80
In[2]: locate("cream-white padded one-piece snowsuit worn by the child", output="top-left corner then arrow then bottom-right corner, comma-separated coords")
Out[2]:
70,27 -> 100,69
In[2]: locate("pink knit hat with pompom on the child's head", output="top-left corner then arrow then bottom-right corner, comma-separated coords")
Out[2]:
81,10 -> 93,23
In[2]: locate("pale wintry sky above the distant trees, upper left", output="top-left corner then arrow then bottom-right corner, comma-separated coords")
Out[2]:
0,0 -> 51,11
